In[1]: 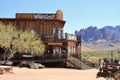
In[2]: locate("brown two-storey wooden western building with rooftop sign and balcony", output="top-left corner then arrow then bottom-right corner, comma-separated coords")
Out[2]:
0,10 -> 81,61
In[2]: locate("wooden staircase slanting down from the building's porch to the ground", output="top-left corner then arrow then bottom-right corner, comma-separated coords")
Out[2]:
67,54 -> 92,70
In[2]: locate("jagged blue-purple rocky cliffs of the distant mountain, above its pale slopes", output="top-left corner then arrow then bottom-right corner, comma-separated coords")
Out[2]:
75,25 -> 120,43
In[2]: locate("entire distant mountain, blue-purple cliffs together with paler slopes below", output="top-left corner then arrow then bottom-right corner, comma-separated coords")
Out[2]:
75,25 -> 120,48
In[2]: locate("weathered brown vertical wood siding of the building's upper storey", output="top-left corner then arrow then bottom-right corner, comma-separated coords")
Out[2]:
0,19 -> 65,36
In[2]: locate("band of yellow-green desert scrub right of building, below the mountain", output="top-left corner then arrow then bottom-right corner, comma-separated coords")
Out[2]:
81,51 -> 120,67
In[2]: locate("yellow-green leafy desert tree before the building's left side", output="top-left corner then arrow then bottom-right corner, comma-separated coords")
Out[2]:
0,23 -> 45,61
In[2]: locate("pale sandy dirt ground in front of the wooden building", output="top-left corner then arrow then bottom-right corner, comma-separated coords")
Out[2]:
0,67 -> 105,80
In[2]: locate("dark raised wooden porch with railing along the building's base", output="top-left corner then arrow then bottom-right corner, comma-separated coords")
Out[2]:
11,53 -> 67,63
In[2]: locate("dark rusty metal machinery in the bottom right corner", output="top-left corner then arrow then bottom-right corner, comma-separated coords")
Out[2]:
97,58 -> 120,80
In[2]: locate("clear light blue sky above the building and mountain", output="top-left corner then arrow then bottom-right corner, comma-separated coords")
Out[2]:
0,0 -> 120,34
